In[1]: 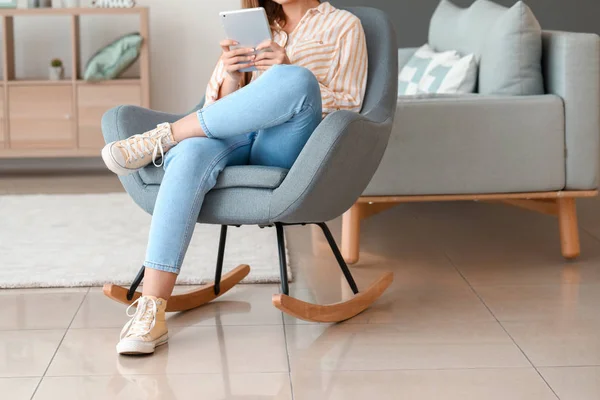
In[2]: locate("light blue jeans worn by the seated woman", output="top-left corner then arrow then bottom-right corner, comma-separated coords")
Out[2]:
144,65 -> 322,274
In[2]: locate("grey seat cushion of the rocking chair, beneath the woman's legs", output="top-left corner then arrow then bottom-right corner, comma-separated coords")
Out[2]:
140,165 -> 288,190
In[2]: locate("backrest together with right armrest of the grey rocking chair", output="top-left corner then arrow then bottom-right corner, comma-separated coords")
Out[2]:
271,7 -> 398,222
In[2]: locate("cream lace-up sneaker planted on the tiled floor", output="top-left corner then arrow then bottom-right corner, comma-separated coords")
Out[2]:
117,296 -> 169,354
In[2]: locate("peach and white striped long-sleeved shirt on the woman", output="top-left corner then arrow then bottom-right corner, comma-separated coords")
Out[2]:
206,1 -> 368,116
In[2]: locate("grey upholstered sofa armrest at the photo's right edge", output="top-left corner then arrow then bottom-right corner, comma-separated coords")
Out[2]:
543,31 -> 600,190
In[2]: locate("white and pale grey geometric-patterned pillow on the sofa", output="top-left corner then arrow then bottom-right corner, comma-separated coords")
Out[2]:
398,44 -> 477,96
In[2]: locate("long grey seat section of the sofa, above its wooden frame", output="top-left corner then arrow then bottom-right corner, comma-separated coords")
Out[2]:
363,95 -> 565,196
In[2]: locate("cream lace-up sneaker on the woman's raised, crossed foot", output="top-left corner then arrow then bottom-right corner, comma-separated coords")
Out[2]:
102,123 -> 177,175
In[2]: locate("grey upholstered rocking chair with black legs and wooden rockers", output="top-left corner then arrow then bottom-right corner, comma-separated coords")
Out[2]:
102,7 -> 398,322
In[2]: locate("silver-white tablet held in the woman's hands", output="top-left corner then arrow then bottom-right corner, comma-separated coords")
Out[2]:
219,7 -> 273,72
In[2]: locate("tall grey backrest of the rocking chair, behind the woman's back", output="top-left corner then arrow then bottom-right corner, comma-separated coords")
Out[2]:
346,7 -> 398,122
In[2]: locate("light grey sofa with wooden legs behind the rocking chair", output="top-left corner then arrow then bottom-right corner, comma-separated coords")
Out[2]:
342,0 -> 600,263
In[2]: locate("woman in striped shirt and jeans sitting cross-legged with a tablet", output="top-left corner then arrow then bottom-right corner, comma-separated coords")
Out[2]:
102,0 -> 367,354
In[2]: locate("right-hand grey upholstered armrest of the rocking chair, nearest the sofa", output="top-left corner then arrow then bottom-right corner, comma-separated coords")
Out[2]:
270,111 -> 392,223
